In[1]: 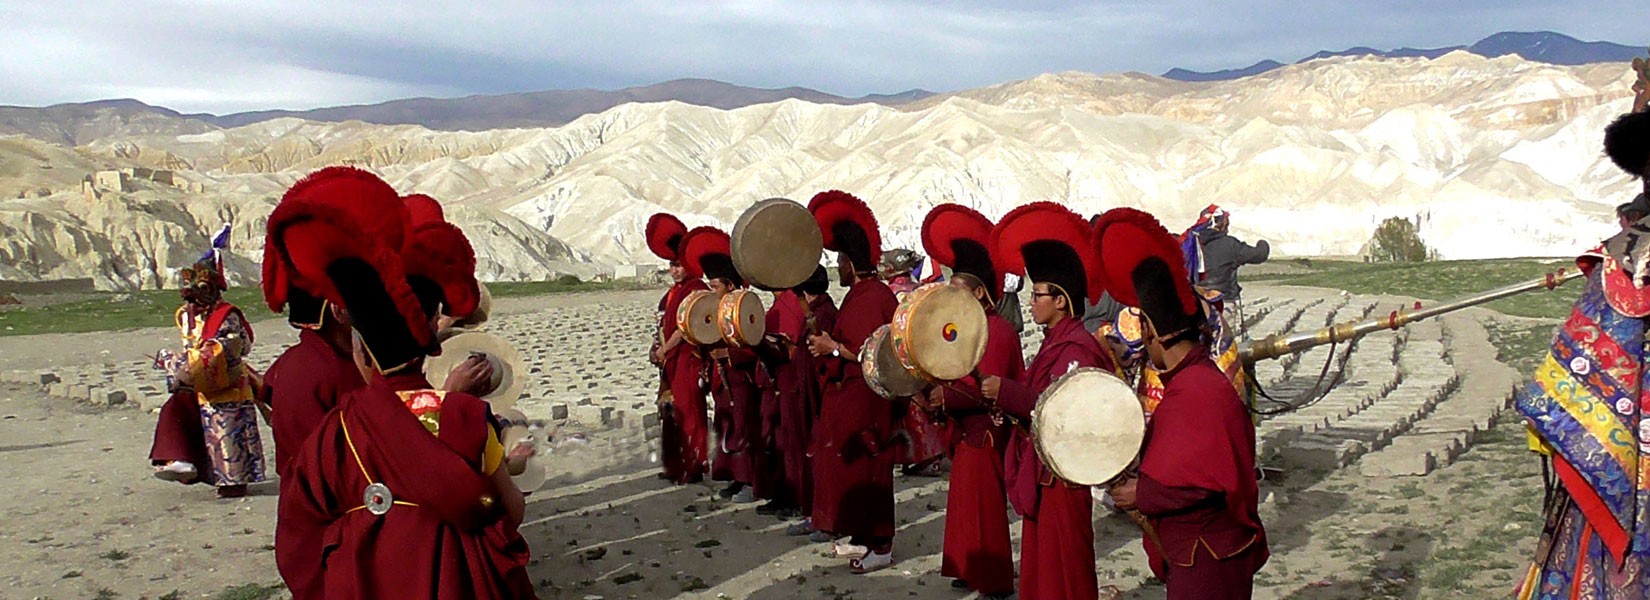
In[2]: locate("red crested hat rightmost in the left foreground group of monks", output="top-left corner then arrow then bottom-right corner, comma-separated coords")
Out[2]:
401,195 -> 482,318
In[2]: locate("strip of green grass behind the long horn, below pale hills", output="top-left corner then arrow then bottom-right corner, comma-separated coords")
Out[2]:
1242,259 -> 1581,318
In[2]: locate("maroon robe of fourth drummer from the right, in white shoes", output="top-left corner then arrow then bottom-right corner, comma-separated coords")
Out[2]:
813,279 -> 899,544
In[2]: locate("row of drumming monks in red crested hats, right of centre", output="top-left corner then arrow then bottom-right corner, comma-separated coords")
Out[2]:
647,191 -> 1267,600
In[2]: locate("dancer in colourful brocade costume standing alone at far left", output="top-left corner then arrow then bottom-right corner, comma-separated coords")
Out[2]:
149,249 -> 264,498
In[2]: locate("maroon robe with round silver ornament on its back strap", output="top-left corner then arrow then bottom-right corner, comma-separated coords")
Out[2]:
276,371 -> 535,600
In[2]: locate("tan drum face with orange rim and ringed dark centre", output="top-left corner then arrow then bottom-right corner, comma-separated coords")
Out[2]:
889,284 -> 987,381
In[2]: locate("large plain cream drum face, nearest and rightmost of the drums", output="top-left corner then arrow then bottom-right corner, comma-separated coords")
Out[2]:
1031,368 -> 1145,485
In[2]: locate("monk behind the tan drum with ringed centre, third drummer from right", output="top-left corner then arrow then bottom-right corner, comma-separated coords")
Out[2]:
922,204 -> 1025,598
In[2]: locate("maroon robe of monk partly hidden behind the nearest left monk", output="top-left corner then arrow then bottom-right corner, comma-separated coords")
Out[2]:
264,330 -> 363,488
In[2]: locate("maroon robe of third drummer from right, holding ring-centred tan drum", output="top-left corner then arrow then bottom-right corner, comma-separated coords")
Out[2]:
939,312 -> 1025,595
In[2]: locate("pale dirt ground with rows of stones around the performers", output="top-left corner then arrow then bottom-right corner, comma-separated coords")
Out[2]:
0,264 -> 1574,598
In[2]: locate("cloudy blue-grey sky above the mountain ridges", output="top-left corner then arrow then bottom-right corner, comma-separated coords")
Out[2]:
0,0 -> 1650,114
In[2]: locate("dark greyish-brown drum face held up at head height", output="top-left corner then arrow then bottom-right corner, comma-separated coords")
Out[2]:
729,198 -> 825,290
